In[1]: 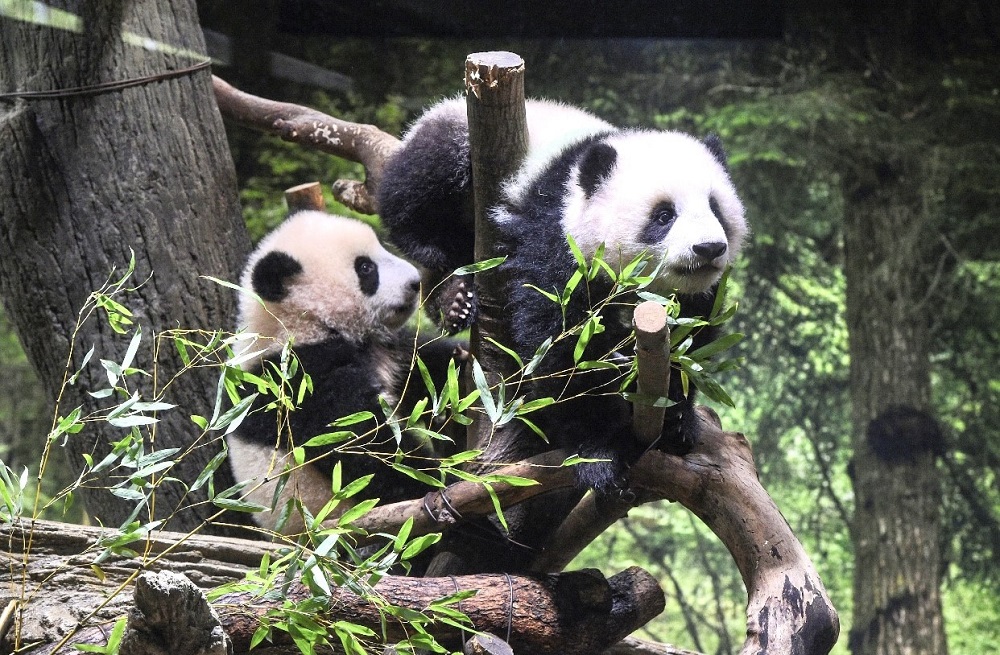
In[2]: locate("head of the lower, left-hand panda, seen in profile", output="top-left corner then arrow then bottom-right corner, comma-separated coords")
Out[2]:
239,211 -> 420,352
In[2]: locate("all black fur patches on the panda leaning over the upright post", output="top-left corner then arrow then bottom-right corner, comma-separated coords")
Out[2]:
378,115 -> 725,493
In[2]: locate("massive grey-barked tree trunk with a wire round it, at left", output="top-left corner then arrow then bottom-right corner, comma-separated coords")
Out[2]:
0,0 -> 249,530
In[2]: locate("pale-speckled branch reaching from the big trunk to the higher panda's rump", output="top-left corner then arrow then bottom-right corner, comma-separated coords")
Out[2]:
212,76 -> 399,214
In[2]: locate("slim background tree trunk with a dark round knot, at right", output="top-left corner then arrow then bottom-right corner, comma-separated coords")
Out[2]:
844,145 -> 947,655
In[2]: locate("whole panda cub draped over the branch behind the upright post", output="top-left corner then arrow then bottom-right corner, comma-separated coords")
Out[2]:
378,98 -> 747,492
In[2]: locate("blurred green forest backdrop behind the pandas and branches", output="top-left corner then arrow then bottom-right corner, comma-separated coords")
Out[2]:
0,2 -> 1000,654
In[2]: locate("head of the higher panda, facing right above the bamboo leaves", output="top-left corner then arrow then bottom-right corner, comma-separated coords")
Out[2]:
562,130 -> 747,294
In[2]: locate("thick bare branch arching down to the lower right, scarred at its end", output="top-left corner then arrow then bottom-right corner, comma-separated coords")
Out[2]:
631,408 -> 840,655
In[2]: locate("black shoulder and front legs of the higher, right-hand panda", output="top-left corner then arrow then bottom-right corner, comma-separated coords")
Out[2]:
502,142 -> 715,493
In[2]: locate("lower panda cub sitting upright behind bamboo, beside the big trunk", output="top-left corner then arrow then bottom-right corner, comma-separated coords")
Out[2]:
228,211 -> 456,533
